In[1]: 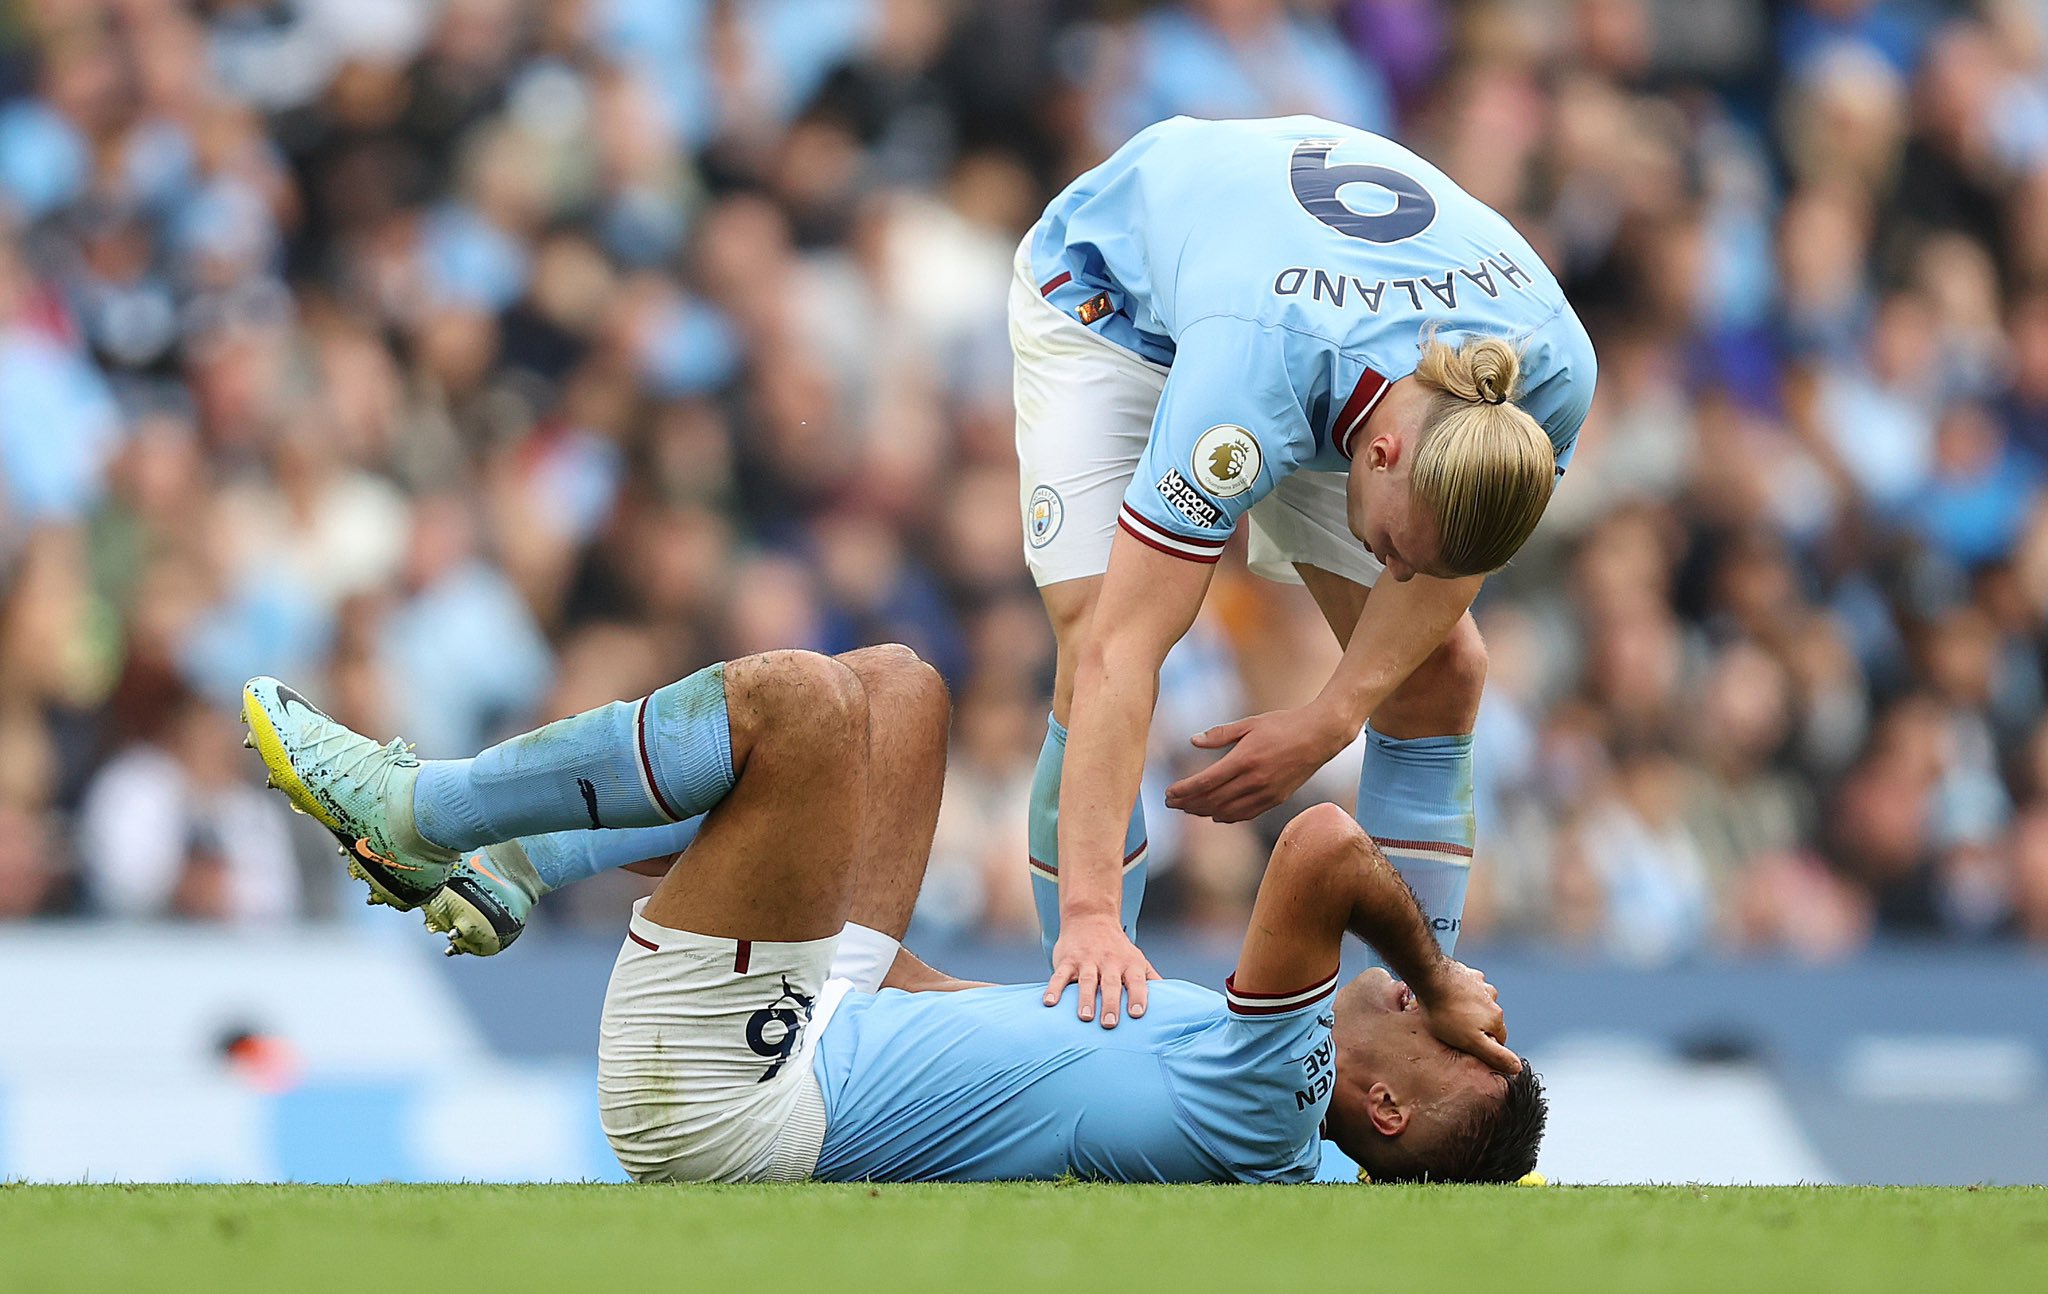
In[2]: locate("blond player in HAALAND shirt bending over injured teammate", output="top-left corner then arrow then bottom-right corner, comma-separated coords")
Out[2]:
1010,117 -> 1593,1026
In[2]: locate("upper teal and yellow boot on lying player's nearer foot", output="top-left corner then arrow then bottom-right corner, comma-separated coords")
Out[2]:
242,678 -> 461,909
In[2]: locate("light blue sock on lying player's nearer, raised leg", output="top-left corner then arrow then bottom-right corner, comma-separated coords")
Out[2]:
412,665 -> 733,850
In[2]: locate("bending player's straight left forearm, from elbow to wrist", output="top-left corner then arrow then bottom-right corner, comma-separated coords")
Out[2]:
1059,645 -> 1159,921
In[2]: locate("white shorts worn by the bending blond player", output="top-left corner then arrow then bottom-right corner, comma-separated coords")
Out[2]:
1010,235 -> 1384,588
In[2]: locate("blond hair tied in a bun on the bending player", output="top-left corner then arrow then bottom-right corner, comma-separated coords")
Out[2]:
1409,336 -> 1556,575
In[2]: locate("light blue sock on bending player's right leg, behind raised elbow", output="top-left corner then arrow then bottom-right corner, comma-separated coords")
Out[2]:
1358,727 -> 1475,956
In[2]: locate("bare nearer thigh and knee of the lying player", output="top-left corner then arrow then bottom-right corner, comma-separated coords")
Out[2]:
647,651 -> 868,942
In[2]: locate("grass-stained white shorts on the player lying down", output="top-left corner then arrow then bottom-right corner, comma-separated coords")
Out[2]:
598,903 -> 838,1181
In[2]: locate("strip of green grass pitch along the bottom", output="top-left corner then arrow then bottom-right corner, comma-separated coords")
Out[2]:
0,1183 -> 2048,1294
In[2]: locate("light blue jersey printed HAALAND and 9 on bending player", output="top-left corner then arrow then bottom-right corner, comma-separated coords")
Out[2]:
1030,117 -> 1595,561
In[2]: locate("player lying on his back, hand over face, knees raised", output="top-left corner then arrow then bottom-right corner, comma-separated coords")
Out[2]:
244,647 -> 1544,1181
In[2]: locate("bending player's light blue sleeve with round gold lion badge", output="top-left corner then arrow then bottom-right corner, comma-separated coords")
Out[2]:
1116,315 -> 1315,563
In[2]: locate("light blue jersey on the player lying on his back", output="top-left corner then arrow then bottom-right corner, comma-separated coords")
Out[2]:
813,977 -> 1335,1181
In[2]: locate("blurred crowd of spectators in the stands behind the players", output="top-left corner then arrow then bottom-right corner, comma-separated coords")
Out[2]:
0,0 -> 2048,962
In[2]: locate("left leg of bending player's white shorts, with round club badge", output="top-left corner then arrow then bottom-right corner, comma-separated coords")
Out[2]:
1010,246 -> 1165,588
